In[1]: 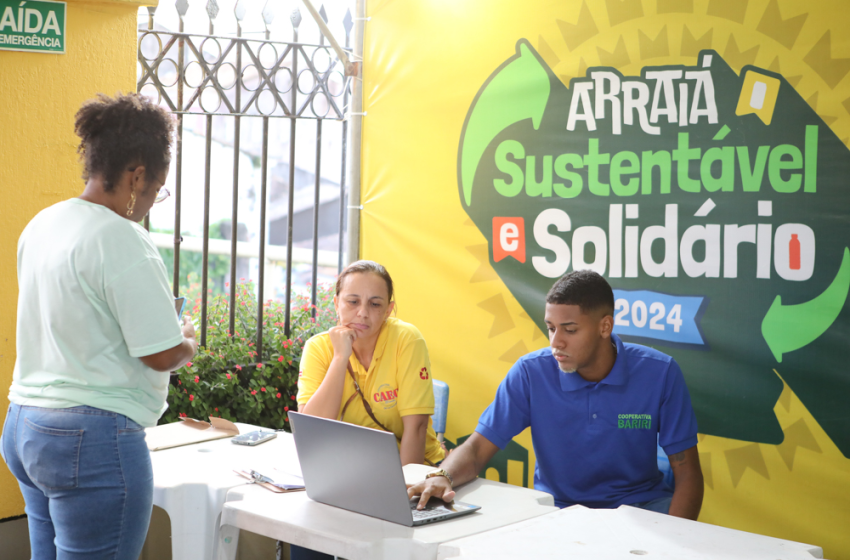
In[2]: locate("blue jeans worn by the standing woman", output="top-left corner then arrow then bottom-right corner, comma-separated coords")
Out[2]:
0,404 -> 153,560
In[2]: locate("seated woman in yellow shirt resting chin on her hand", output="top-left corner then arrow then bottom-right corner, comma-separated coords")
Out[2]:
298,261 -> 445,465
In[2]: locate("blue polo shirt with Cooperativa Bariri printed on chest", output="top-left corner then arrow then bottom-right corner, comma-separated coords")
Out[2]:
475,335 -> 697,508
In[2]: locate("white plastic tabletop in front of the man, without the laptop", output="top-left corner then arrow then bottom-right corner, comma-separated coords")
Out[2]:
437,506 -> 823,560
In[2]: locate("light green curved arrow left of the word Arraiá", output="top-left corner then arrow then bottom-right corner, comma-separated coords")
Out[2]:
460,39 -> 551,206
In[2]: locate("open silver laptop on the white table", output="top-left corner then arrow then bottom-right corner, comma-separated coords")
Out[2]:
289,412 -> 481,527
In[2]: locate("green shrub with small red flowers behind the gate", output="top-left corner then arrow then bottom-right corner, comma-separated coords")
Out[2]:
160,274 -> 335,431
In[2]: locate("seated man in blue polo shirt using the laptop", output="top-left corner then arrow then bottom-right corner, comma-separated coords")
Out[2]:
408,270 -> 703,519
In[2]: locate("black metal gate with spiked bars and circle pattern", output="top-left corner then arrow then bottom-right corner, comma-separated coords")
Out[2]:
137,0 -> 353,355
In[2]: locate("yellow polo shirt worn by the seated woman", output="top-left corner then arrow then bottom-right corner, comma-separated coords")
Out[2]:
298,317 -> 445,463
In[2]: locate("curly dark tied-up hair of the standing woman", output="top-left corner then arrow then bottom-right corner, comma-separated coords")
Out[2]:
74,93 -> 174,192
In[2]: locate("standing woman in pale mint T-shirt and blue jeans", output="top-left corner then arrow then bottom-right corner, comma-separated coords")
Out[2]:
0,94 -> 197,560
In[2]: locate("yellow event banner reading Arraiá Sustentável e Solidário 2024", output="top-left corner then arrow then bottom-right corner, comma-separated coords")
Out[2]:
361,0 -> 850,560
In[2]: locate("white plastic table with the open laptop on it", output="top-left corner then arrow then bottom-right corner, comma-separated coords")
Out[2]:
218,465 -> 557,560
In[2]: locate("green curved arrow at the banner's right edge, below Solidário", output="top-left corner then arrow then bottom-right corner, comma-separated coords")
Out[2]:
761,247 -> 850,362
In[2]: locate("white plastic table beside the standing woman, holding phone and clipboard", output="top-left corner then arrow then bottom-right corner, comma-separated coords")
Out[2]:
144,424 -> 295,560
